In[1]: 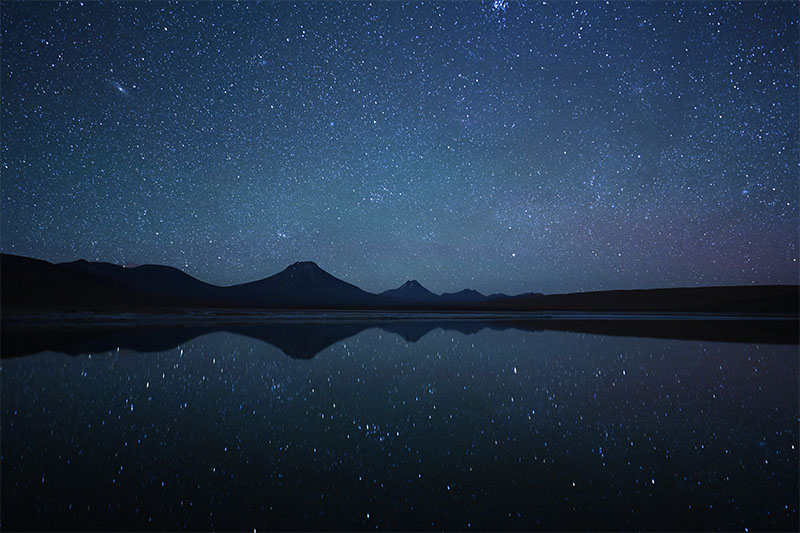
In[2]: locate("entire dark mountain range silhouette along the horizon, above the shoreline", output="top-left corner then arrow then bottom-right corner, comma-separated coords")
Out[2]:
0,254 -> 800,314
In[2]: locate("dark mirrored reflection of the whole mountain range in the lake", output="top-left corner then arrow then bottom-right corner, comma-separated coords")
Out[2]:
0,317 -> 800,359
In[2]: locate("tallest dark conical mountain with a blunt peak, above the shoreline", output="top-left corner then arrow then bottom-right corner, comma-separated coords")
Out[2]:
226,261 -> 386,307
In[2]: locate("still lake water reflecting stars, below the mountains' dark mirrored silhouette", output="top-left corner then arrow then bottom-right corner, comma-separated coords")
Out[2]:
0,318 -> 800,531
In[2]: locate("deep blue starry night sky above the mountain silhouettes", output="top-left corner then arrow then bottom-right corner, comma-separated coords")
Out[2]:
0,0 -> 800,293
